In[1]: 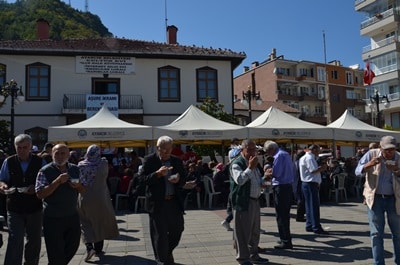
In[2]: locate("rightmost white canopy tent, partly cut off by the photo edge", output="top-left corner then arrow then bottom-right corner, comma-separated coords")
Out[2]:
327,110 -> 400,145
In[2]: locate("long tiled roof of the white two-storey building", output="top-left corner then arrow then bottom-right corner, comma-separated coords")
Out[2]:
0,38 -> 246,64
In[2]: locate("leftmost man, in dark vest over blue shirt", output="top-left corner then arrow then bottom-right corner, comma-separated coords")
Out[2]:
0,134 -> 45,265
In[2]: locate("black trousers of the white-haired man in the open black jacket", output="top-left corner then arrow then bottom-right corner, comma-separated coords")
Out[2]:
149,199 -> 184,265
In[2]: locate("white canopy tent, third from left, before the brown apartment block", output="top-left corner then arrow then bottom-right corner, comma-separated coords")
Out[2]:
247,107 -> 333,144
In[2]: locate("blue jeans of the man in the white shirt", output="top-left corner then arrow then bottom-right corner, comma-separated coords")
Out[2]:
301,182 -> 322,232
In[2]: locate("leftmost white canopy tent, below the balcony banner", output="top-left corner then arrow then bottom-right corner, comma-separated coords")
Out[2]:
48,105 -> 153,148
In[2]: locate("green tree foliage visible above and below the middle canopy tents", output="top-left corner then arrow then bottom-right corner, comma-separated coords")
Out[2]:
191,97 -> 239,160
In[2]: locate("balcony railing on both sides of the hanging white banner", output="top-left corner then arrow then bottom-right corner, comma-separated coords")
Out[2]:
63,94 -> 143,110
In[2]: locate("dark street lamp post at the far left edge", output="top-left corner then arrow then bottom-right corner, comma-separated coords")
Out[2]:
0,79 -> 25,151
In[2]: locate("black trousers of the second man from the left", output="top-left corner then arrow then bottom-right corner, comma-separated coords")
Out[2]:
43,214 -> 81,265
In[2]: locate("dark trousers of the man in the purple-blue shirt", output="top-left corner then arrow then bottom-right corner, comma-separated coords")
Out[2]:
273,184 -> 293,243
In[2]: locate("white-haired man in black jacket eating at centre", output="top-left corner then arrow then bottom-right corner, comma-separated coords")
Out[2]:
140,136 -> 186,265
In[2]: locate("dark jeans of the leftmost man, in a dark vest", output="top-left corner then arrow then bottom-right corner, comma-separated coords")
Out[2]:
4,210 -> 42,265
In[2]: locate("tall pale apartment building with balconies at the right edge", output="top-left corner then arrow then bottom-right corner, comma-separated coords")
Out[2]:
355,0 -> 400,129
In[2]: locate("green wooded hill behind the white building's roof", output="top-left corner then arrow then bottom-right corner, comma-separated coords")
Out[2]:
0,0 -> 112,40
